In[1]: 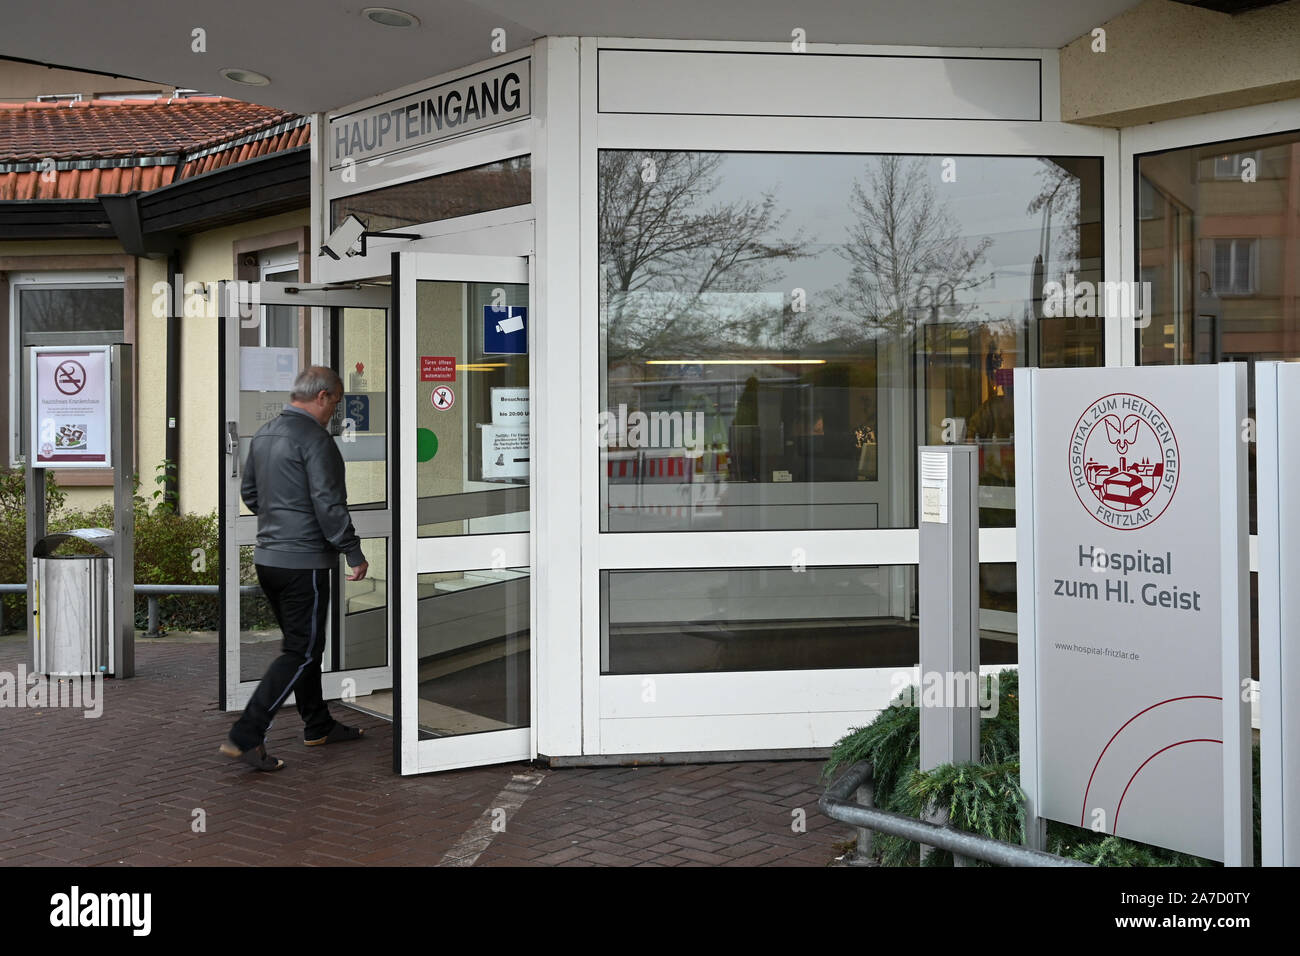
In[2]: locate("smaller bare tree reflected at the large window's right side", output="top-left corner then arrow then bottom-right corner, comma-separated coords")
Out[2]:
832,155 -> 993,341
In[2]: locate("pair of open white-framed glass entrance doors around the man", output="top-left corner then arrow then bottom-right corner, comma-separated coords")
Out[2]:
220,252 -> 533,773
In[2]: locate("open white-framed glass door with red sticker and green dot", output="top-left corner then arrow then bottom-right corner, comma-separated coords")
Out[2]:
391,250 -> 536,774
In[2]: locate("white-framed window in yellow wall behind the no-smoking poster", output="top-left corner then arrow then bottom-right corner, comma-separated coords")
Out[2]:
9,272 -> 127,466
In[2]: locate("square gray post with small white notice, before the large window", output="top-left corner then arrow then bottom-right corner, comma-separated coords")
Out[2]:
917,445 -> 979,853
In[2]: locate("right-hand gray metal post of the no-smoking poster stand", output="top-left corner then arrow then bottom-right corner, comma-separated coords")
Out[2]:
109,345 -> 135,678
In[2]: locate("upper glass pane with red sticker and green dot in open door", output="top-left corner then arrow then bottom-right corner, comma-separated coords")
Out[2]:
408,281 -> 529,537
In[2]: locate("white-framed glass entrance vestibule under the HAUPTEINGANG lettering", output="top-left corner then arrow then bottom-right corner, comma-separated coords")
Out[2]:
222,38 -> 1294,773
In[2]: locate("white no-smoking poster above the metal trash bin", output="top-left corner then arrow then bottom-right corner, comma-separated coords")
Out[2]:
27,345 -> 113,468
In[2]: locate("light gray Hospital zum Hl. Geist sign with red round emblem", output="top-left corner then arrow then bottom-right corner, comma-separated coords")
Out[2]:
1014,364 -> 1252,865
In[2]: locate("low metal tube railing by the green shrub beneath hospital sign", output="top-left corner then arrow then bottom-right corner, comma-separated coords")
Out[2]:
818,760 -> 1091,866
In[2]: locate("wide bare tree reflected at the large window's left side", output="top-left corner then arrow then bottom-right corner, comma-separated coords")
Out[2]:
599,150 -> 807,363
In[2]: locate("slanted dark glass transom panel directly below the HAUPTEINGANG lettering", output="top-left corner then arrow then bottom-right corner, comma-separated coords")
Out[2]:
330,156 -> 533,232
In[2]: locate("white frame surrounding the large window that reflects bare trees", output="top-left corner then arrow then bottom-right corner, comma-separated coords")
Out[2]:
580,38 -> 1122,754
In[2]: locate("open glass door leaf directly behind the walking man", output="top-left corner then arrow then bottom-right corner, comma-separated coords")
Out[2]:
218,282 -> 393,715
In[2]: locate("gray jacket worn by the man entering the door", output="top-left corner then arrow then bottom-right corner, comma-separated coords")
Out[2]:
241,405 -> 365,568
